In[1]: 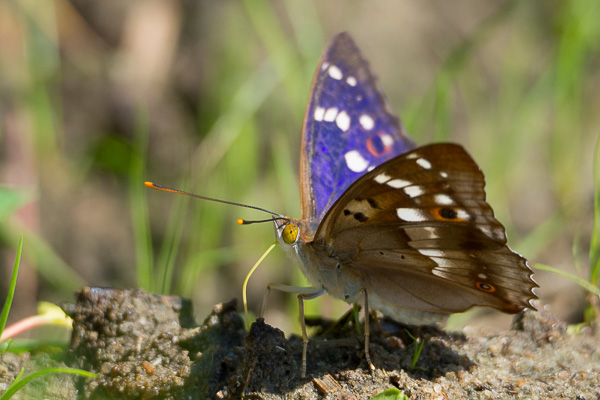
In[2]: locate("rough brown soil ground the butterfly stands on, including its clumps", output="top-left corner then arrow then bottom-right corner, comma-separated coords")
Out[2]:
0,287 -> 600,399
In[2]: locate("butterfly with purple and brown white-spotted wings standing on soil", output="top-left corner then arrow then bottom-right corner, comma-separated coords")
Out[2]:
264,33 -> 538,374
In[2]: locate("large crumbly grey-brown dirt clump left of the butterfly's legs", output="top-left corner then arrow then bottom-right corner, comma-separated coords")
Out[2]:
63,287 -> 245,399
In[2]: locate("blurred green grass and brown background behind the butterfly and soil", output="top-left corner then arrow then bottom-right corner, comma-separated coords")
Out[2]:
0,0 -> 600,330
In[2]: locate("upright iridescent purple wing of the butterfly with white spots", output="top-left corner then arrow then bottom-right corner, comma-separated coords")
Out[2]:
300,33 -> 416,234
